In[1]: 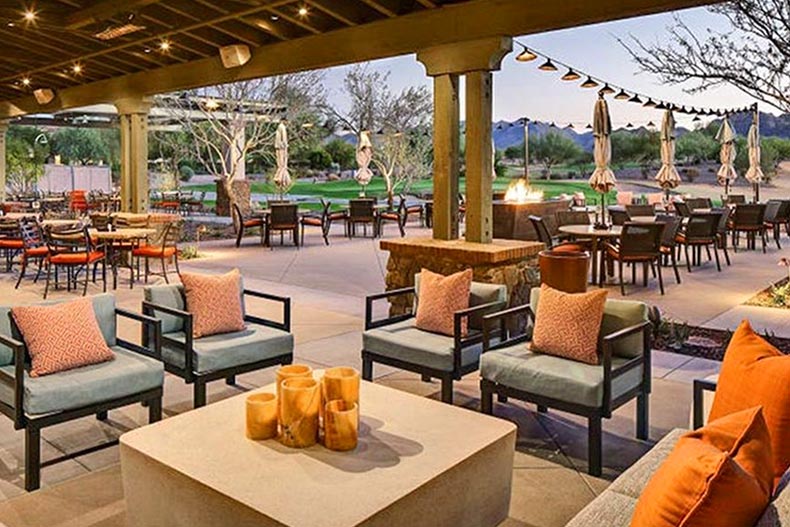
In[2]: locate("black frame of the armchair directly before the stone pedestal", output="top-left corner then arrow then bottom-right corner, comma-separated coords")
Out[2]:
362,286 -> 502,404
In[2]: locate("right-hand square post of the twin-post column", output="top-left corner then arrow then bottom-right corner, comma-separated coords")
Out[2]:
466,71 -> 494,243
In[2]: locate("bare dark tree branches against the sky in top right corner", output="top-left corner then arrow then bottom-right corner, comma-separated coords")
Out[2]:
621,0 -> 790,112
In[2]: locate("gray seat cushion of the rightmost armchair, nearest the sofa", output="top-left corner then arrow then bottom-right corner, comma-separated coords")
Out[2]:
480,344 -> 642,407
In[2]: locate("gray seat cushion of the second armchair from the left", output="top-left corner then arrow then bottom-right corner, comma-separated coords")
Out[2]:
162,323 -> 294,373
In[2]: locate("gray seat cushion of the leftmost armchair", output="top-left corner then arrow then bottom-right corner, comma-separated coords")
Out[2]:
0,346 -> 164,415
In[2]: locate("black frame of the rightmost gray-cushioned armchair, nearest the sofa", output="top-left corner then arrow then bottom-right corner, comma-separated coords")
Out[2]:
480,304 -> 652,476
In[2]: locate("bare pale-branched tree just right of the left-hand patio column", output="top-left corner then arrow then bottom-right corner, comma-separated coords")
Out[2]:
160,72 -> 324,209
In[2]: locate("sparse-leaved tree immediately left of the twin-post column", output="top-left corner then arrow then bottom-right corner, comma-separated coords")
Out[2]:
327,64 -> 433,205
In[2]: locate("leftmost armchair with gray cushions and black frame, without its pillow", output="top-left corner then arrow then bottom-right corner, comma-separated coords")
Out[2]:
0,294 -> 164,491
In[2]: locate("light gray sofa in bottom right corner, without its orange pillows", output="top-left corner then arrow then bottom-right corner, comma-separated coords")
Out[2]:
566,380 -> 790,527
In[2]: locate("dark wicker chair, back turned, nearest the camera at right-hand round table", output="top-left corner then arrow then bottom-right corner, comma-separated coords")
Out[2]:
601,222 -> 664,296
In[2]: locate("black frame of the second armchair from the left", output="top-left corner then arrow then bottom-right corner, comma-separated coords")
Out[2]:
143,289 -> 293,408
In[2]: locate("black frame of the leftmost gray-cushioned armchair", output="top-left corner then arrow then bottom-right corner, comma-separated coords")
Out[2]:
0,308 -> 162,492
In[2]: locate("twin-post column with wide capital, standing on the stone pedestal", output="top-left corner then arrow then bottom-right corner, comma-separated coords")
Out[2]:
417,37 -> 513,243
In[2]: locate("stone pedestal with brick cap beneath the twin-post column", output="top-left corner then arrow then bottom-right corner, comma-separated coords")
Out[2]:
381,238 -> 544,315
